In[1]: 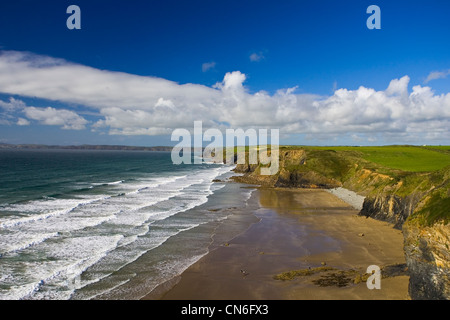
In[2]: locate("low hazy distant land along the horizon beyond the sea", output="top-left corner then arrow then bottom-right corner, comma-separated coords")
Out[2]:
0,143 -> 172,151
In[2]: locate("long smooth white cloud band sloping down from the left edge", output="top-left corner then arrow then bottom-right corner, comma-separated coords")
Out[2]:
0,51 -> 220,109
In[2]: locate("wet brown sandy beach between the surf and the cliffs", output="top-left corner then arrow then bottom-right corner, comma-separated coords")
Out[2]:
145,188 -> 409,300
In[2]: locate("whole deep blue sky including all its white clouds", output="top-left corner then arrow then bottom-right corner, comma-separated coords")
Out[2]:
0,0 -> 450,146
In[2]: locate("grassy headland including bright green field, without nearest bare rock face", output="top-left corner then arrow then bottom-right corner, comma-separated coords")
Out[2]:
236,146 -> 450,225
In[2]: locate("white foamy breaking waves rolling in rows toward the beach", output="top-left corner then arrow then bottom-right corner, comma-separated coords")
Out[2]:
0,162 -> 231,299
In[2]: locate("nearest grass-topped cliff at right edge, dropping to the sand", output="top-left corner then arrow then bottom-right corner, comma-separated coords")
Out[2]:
360,167 -> 450,300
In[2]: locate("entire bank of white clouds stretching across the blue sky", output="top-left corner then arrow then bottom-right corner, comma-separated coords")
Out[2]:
0,51 -> 450,143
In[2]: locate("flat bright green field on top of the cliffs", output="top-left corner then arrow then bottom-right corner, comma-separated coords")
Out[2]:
302,146 -> 450,172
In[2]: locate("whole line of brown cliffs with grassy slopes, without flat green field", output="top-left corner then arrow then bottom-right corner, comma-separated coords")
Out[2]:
235,147 -> 450,299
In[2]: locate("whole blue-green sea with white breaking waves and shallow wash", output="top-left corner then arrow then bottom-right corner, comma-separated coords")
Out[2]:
0,150 -> 253,300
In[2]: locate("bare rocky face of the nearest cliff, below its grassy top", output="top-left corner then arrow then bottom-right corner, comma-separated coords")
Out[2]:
360,188 -> 450,300
